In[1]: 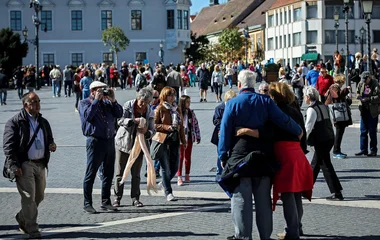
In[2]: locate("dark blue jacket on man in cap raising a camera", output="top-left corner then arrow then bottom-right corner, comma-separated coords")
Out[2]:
79,97 -> 123,139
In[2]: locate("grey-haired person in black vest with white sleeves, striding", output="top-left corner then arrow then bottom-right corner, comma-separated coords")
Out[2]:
304,86 -> 344,201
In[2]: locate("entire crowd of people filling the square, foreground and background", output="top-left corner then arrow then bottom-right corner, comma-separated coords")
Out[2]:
0,49 -> 380,239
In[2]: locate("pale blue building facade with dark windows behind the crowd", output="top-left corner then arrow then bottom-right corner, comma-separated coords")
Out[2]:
0,0 -> 191,66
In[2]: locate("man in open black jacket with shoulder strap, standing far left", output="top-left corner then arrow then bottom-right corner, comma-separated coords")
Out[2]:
3,92 -> 56,239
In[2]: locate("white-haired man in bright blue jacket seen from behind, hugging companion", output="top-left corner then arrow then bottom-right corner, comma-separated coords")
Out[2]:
218,70 -> 303,239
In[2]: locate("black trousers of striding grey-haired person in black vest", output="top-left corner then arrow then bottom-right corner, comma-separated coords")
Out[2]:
311,139 -> 343,193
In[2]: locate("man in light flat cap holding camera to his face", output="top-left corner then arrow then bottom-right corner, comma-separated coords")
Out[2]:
79,81 -> 123,214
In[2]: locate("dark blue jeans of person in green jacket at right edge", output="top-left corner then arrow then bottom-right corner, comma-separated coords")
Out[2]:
360,110 -> 379,153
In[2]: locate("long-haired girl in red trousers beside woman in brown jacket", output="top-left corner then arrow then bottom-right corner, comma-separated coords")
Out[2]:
177,95 -> 201,186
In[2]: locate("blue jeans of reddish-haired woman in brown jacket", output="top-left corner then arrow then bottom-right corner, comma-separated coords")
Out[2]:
160,143 -> 179,196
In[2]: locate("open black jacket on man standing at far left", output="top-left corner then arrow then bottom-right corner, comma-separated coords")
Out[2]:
3,109 -> 54,170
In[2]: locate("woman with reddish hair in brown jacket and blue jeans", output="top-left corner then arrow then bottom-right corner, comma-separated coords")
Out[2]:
154,87 -> 187,201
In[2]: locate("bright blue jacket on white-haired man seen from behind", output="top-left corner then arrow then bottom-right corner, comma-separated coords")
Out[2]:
218,89 -> 302,162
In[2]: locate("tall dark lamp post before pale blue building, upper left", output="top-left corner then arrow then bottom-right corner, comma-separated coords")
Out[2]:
22,0 -> 42,90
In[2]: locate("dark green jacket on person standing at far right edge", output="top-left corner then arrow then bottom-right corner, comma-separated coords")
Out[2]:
357,80 -> 380,118
